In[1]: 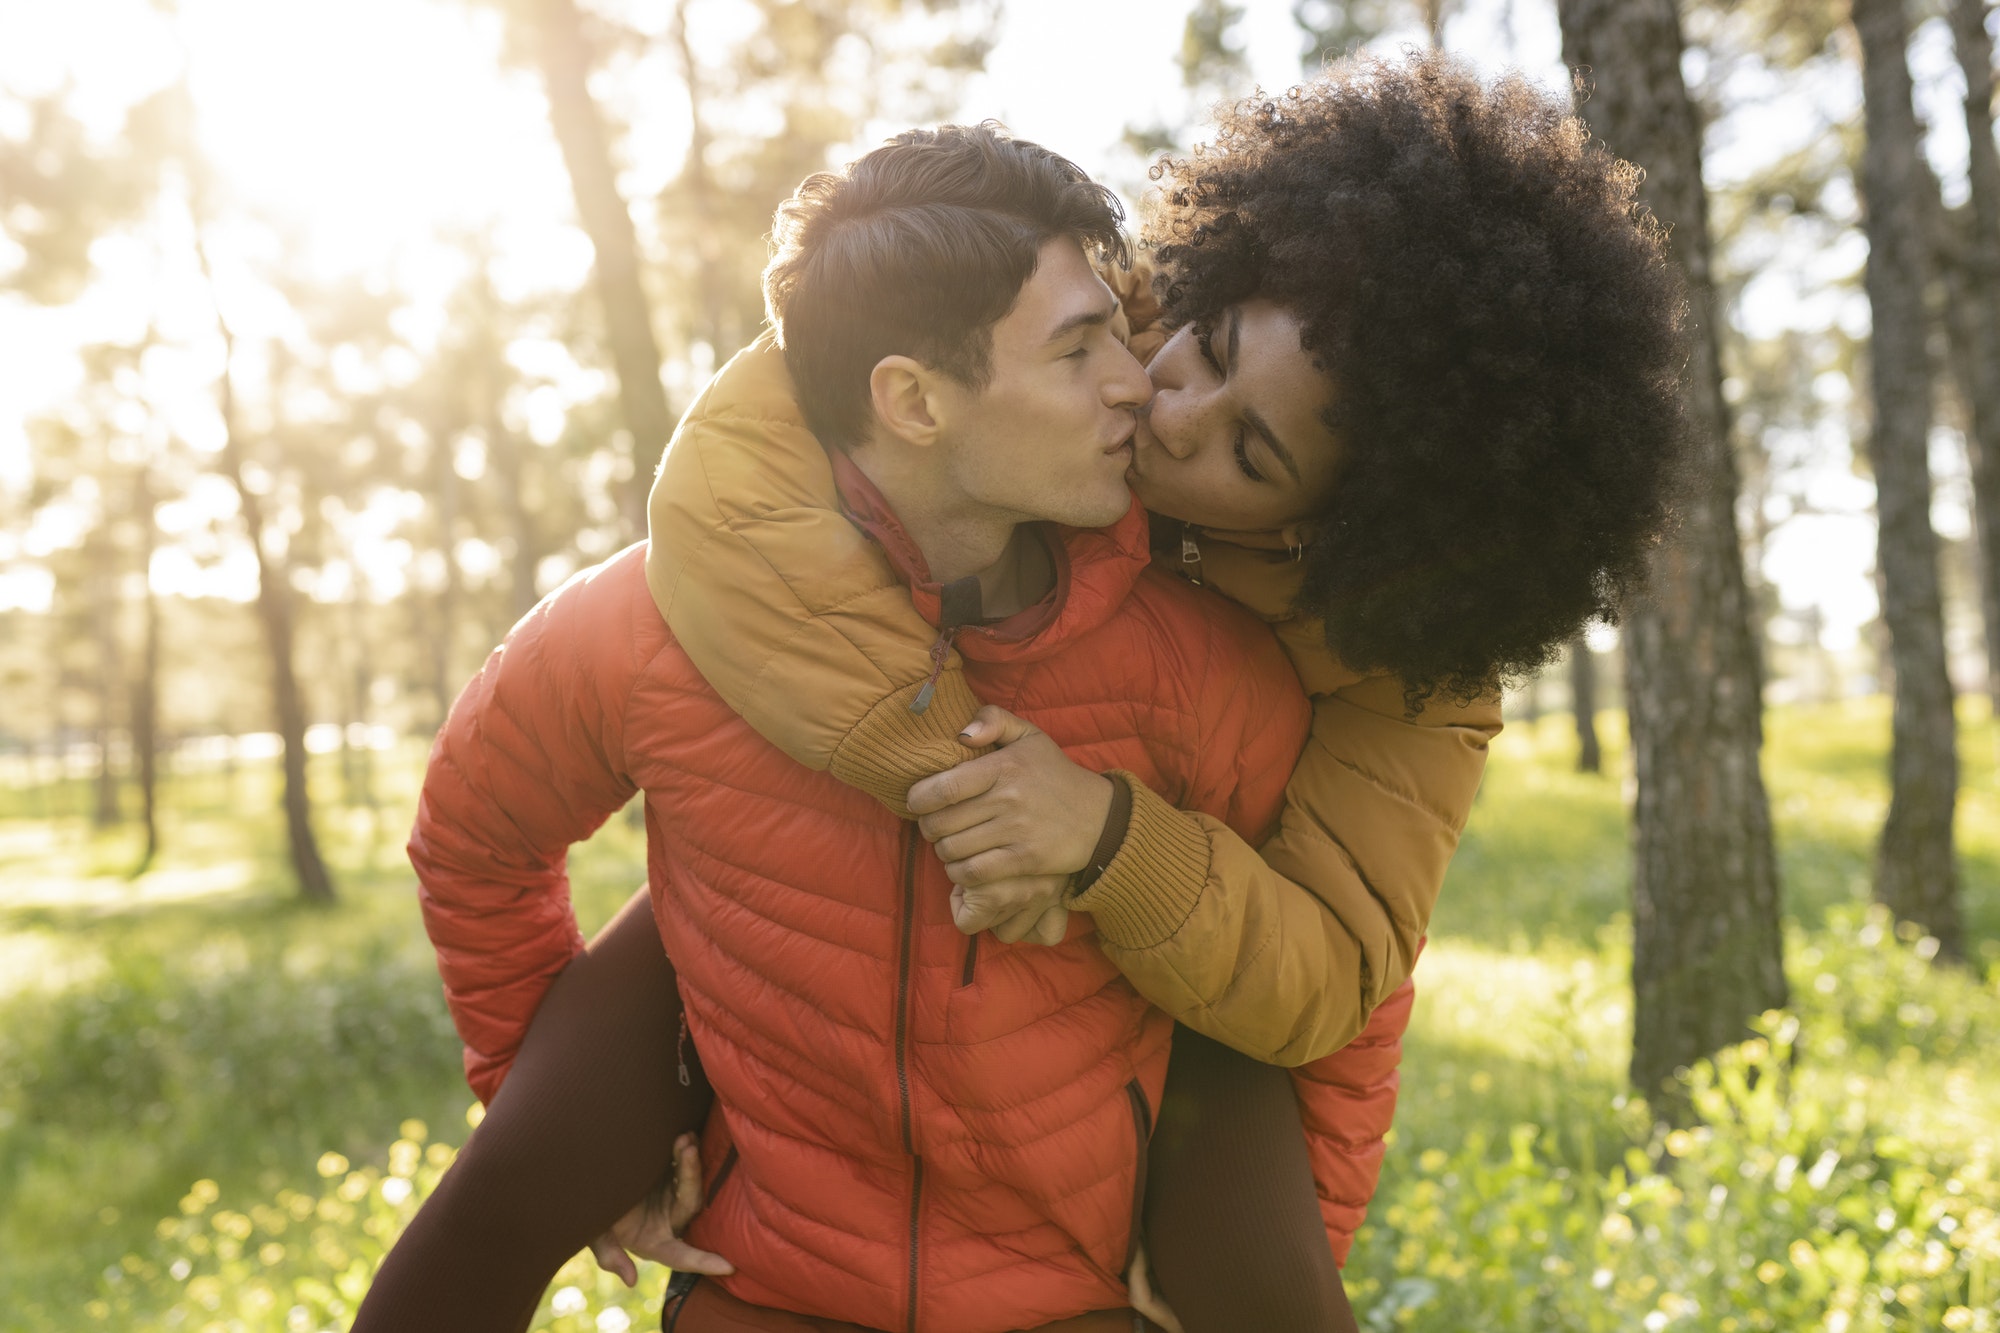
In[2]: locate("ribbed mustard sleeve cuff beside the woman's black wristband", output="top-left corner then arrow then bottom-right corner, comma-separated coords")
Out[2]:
1070,773 -> 1208,949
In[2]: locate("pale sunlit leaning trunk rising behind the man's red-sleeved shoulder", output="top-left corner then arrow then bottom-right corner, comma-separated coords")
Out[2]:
532,0 -> 674,536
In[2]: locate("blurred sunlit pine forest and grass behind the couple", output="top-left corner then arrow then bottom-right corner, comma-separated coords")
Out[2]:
0,0 -> 2000,1333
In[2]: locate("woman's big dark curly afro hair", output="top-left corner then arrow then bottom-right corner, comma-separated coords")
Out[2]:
1148,52 -> 1686,705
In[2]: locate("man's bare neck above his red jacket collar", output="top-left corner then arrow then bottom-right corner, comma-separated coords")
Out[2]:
852,446 -> 1056,620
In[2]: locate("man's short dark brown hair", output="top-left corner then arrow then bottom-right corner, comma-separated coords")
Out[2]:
764,122 -> 1126,448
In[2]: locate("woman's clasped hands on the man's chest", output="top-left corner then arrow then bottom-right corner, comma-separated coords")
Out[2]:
908,705 -> 1112,945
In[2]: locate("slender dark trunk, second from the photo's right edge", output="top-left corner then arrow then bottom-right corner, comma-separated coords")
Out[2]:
1852,0 -> 1964,959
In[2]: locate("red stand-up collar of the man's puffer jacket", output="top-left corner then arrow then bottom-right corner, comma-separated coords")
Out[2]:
826,448 -> 1150,662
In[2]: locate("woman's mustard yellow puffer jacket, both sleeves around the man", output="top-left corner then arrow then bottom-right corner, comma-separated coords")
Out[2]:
646,272 -> 1500,1065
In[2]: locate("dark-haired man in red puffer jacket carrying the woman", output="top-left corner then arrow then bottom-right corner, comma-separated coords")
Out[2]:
364,128 -> 1392,1333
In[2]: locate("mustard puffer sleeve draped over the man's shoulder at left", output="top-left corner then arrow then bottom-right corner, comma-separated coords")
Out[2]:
646,334 -> 978,815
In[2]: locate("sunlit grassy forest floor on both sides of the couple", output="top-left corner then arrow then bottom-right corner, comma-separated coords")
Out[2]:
0,701 -> 2000,1333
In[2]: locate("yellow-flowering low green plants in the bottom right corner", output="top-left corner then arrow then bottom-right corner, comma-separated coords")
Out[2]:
1348,1013 -> 2000,1333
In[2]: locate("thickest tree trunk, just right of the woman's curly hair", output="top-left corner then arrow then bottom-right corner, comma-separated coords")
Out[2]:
1556,0 -> 1786,1115
